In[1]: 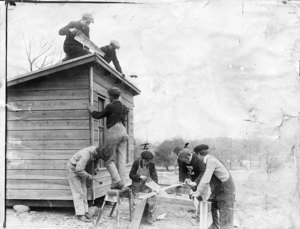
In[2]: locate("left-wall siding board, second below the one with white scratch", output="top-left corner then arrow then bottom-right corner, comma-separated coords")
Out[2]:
7,120 -> 89,131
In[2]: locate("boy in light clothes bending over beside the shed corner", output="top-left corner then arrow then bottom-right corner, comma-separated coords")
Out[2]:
66,146 -> 101,222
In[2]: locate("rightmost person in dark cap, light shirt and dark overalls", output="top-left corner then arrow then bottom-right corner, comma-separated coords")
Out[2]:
194,144 -> 235,229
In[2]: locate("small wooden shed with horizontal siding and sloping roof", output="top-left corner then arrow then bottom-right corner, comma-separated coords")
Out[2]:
6,54 -> 140,206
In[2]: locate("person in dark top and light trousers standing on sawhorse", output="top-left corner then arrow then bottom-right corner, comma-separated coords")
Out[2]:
89,87 -> 128,189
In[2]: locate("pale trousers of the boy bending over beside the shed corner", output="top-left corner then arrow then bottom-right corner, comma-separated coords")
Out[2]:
66,161 -> 89,215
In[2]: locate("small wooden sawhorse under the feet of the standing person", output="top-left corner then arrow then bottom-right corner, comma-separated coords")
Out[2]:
95,187 -> 132,227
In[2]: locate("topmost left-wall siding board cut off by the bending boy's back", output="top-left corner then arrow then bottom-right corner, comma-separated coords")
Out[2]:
6,149 -> 77,160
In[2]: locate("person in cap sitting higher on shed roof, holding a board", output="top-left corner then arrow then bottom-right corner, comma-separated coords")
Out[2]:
59,13 -> 94,61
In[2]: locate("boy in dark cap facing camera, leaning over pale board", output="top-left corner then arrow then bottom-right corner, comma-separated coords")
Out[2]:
129,150 -> 158,224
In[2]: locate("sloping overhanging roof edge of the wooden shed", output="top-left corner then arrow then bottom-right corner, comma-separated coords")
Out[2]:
7,53 -> 141,95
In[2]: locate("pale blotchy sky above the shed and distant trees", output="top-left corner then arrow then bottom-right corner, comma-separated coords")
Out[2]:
4,0 -> 300,141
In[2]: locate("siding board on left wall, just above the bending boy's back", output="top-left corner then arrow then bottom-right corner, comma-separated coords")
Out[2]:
7,139 -> 90,150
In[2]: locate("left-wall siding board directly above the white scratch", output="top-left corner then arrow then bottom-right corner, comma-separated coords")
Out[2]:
7,89 -> 89,102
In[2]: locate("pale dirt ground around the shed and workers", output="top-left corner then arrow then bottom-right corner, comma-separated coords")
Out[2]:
6,167 -> 300,229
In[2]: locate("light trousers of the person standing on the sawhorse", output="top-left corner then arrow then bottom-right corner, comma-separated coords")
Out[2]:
105,122 -> 128,183
